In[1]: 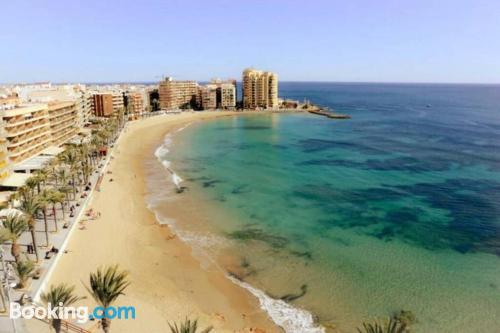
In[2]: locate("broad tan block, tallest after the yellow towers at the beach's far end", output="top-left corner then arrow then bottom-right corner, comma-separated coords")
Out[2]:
159,77 -> 199,109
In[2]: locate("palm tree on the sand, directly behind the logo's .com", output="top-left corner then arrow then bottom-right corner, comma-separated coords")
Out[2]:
87,265 -> 130,333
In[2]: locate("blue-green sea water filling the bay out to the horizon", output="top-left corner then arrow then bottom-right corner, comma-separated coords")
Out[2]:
151,83 -> 500,332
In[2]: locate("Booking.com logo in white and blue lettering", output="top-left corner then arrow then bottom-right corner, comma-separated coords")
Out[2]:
9,303 -> 135,324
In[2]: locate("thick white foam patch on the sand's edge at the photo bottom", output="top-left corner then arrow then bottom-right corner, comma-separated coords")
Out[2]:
228,276 -> 325,333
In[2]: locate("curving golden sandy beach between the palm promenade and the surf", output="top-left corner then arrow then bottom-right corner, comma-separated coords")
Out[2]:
27,112 -> 282,333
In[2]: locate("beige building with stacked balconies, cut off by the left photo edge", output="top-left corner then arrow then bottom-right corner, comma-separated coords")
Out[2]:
2,104 -> 52,163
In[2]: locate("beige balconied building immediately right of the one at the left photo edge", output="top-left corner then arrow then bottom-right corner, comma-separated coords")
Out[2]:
48,102 -> 78,146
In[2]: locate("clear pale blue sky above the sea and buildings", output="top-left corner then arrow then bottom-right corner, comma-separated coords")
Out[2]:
0,0 -> 500,83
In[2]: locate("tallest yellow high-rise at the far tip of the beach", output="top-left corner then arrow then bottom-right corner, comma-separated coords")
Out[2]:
243,68 -> 278,109
